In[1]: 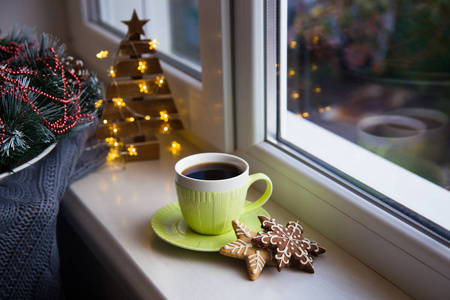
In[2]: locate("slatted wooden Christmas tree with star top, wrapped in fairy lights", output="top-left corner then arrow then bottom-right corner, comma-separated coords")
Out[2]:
96,11 -> 183,162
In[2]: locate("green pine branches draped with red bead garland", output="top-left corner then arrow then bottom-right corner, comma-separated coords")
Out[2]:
0,28 -> 102,172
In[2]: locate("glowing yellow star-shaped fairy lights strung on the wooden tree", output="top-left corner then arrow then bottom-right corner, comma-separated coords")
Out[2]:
96,39 -> 181,162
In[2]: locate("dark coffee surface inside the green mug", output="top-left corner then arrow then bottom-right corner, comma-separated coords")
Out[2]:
181,162 -> 243,180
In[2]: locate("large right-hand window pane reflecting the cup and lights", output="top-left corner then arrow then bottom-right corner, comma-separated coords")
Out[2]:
276,0 -> 450,239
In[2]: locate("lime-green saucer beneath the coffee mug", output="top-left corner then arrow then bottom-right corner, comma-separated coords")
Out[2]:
152,201 -> 270,252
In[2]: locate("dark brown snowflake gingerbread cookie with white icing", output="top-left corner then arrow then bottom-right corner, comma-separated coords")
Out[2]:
252,216 -> 325,273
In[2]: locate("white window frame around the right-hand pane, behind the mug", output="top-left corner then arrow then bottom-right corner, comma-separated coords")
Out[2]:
233,0 -> 450,298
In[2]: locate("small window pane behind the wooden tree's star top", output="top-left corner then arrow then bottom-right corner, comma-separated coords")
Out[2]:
93,0 -> 201,76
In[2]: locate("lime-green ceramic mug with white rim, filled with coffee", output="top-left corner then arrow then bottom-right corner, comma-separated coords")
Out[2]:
175,153 -> 272,235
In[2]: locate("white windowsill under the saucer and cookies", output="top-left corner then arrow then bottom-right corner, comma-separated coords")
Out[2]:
61,134 -> 409,299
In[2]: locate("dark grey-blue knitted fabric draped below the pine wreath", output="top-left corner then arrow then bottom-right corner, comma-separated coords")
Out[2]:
0,127 -> 105,299
